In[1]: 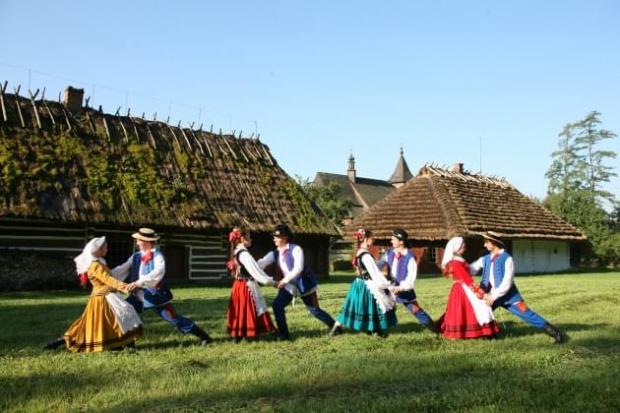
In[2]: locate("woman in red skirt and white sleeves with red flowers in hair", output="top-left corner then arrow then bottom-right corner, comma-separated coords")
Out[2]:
226,228 -> 277,343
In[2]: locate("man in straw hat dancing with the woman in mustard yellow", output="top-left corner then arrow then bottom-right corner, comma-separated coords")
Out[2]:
112,228 -> 213,346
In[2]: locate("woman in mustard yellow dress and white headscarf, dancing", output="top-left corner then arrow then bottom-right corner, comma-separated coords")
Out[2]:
45,237 -> 142,353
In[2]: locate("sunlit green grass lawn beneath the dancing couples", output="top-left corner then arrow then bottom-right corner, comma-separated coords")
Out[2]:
0,272 -> 620,412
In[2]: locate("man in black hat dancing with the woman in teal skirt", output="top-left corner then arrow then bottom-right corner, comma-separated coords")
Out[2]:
377,228 -> 438,333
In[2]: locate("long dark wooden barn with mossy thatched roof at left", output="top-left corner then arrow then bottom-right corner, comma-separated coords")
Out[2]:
0,83 -> 337,282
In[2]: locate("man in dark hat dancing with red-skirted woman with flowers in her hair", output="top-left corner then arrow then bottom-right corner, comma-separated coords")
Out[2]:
258,225 -> 342,340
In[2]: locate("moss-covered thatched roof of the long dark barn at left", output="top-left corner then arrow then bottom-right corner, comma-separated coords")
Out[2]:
0,87 -> 336,234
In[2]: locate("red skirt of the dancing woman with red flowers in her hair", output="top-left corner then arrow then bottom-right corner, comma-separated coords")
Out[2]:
226,280 -> 275,337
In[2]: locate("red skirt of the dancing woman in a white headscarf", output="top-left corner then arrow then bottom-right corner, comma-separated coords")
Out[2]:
437,283 -> 499,338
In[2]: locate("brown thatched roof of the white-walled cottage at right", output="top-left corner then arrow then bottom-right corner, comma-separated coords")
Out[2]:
348,165 -> 586,241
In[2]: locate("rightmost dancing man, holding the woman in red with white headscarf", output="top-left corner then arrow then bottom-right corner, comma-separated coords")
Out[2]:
469,231 -> 567,344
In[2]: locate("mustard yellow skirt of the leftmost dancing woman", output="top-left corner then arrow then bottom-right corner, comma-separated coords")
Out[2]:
63,295 -> 142,353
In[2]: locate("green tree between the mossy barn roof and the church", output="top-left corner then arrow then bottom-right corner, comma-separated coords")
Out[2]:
295,176 -> 352,225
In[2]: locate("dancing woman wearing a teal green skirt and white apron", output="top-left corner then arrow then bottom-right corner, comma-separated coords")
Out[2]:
332,228 -> 396,337
